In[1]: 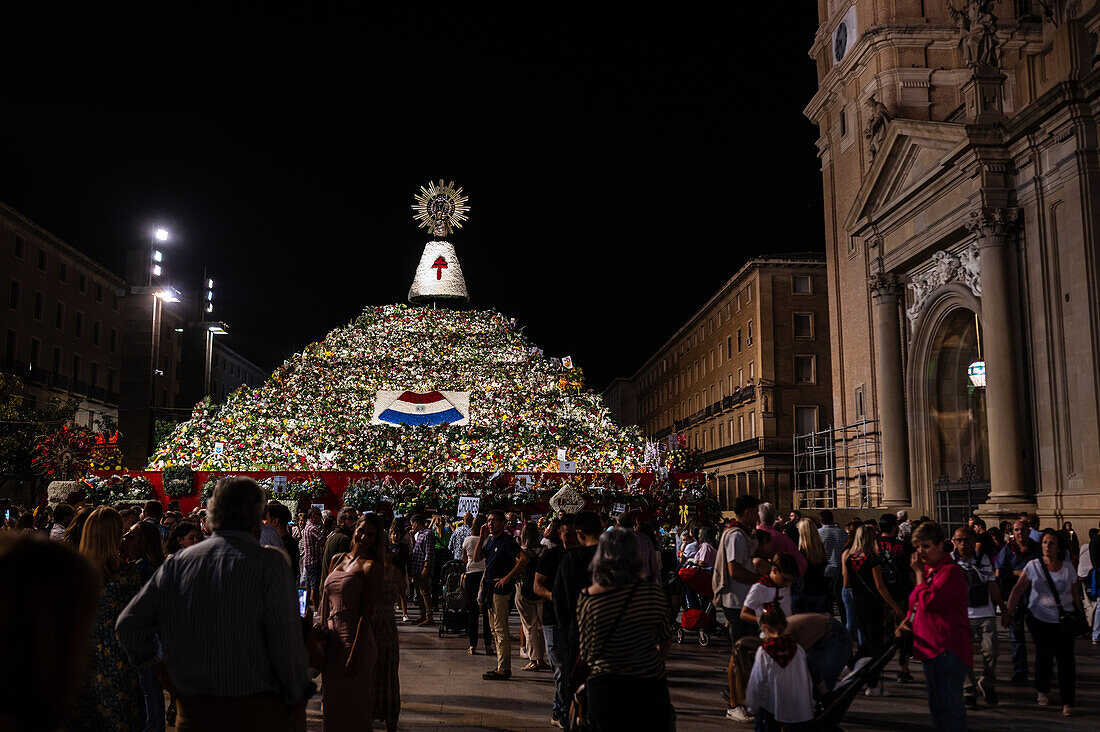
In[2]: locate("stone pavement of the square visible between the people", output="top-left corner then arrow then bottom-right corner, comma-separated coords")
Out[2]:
308,613 -> 1100,732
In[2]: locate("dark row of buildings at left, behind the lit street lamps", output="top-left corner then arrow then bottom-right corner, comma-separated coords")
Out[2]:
0,197 -> 268,467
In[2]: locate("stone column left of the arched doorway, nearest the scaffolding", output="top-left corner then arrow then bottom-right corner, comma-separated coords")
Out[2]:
870,273 -> 912,506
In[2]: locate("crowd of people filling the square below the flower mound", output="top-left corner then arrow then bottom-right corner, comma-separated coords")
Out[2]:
0,478 -> 1100,731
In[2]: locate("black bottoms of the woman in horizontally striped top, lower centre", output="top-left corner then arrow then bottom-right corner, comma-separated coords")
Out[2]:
585,674 -> 673,732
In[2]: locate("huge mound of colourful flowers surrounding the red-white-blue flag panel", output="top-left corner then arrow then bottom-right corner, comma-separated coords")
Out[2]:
150,305 -> 657,473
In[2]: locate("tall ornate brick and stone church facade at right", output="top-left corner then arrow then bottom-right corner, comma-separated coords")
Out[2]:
806,0 -> 1100,523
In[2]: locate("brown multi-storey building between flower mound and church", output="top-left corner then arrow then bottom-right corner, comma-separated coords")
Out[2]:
605,254 -> 833,509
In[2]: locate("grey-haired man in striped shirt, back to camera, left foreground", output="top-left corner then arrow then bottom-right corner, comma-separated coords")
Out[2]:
116,478 -> 311,732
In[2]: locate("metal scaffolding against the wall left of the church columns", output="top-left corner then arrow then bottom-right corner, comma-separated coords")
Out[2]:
794,419 -> 882,510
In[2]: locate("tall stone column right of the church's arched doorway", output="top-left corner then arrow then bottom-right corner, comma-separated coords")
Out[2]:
967,208 -> 1034,513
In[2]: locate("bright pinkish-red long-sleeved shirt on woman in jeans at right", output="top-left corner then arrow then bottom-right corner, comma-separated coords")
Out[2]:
909,555 -> 974,668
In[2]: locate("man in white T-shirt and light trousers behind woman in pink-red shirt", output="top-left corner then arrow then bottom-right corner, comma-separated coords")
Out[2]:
952,526 -> 1008,709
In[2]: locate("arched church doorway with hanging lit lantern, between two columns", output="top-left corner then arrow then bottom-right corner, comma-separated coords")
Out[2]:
925,307 -> 989,483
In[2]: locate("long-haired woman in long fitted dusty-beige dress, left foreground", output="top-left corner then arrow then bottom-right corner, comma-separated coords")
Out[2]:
321,514 -> 385,732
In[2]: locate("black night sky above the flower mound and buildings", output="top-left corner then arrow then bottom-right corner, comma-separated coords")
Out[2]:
0,7 -> 823,389
